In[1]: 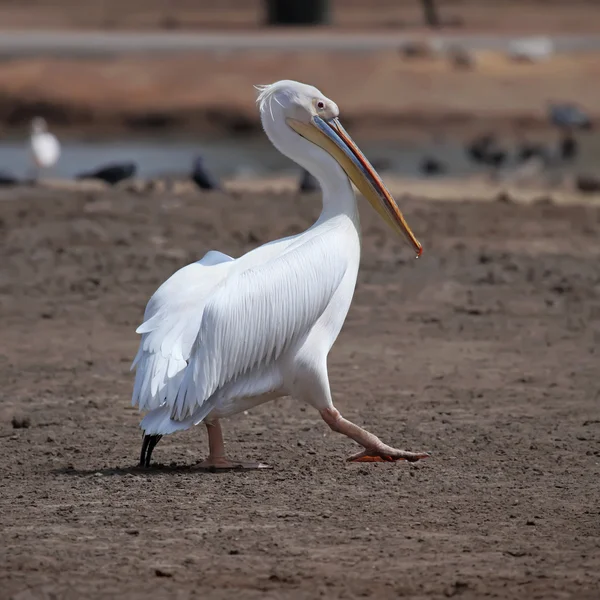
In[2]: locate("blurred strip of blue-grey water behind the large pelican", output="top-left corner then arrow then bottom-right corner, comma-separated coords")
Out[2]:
0,134 -> 600,178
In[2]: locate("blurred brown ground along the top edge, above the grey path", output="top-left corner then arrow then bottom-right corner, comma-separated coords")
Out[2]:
0,0 -> 600,33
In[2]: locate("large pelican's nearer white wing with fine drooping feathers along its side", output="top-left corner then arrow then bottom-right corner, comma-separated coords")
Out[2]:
167,237 -> 347,422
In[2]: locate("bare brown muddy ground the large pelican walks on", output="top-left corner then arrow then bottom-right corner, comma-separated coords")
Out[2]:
0,189 -> 600,600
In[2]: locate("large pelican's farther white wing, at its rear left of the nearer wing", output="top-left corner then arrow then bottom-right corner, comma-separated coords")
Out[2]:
131,251 -> 233,410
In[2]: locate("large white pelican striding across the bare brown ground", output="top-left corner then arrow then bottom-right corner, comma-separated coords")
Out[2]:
132,81 -> 428,470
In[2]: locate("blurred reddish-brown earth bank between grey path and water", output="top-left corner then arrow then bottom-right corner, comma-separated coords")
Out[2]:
0,52 -> 600,138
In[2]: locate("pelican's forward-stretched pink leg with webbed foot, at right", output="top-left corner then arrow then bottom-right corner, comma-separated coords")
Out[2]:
321,408 -> 429,462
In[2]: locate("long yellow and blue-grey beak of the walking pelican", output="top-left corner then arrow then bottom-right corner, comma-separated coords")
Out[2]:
287,116 -> 423,258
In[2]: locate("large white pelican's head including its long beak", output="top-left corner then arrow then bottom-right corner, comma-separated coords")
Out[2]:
257,81 -> 423,257
